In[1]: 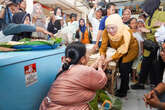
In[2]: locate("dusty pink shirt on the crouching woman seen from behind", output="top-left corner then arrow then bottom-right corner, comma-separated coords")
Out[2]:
40,65 -> 107,110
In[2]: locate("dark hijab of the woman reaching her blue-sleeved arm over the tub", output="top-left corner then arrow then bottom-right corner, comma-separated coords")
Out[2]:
12,12 -> 32,41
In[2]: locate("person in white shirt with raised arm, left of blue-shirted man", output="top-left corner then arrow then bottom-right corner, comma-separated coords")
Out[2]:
88,4 -> 102,44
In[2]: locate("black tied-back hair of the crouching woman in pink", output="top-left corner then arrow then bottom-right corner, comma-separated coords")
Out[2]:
56,42 -> 86,79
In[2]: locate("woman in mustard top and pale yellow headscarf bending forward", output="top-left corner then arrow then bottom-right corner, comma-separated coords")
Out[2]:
99,14 -> 139,97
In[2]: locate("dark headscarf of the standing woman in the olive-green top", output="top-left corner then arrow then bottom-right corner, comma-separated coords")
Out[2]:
142,0 -> 160,26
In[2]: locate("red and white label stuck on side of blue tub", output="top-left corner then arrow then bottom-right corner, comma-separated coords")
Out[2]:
24,63 -> 38,87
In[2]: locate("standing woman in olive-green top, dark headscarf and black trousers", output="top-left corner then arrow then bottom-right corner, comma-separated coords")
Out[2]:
131,0 -> 165,89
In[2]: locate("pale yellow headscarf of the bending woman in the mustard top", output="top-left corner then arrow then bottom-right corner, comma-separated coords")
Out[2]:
105,14 -> 131,54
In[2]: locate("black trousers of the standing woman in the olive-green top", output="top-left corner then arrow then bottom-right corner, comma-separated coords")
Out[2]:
139,56 -> 164,86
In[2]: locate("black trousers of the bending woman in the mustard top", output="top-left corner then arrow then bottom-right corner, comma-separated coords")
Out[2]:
119,60 -> 132,94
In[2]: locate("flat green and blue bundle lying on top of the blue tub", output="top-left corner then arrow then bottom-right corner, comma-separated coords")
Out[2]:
0,38 -> 62,51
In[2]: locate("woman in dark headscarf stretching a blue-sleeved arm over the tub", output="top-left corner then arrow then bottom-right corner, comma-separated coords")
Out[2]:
3,12 -> 53,41
